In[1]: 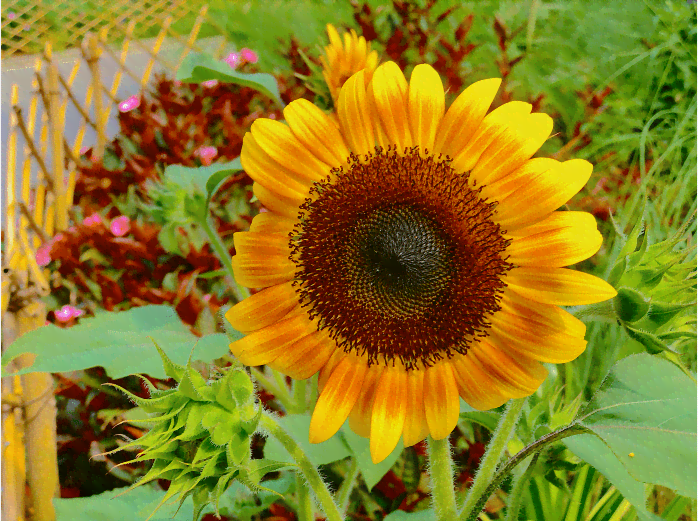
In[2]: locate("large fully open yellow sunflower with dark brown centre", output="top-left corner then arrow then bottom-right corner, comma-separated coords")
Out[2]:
226,62 -> 615,462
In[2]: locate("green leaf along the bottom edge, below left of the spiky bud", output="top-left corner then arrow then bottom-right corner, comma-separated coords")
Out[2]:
53,486 -> 204,521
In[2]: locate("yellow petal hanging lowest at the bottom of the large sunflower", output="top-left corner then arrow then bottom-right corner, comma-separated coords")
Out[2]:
370,365 -> 408,463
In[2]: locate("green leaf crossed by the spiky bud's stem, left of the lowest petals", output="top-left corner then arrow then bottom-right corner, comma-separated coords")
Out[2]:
264,414 -> 351,466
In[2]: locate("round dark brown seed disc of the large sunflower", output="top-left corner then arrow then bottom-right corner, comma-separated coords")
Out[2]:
291,144 -> 511,368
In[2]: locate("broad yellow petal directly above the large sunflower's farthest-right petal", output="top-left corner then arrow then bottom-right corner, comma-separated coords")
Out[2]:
506,212 -> 603,268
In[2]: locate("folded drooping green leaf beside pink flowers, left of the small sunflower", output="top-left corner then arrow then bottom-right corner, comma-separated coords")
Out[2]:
177,53 -> 284,108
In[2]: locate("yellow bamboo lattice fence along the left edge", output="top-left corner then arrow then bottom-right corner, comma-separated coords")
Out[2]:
2,6 -> 227,521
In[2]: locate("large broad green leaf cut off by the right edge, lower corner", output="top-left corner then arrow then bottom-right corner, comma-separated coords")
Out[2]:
579,354 -> 697,498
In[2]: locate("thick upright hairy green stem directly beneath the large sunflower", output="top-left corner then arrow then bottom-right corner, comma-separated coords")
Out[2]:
428,436 -> 456,521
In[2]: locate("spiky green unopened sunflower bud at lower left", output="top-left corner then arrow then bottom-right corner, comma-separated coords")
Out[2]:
104,346 -> 288,520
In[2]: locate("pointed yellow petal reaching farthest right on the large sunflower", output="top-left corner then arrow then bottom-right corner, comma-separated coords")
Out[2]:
506,266 -> 616,306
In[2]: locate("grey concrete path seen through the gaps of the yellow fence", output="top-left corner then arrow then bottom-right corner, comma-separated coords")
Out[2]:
0,37 -> 227,224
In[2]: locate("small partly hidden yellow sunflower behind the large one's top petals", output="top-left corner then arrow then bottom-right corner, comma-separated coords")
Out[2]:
320,24 -> 378,106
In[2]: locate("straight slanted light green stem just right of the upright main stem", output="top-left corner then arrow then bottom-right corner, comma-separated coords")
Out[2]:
459,398 -> 526,521
